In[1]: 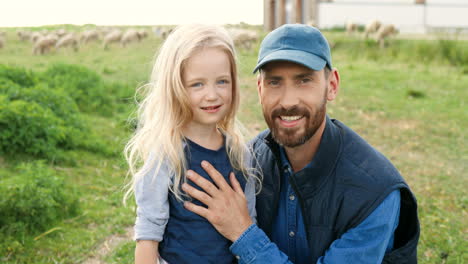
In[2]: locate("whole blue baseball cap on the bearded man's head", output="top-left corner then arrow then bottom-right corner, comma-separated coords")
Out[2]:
253,24 -> 332,73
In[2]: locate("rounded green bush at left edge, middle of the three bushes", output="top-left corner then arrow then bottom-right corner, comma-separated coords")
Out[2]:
0,95 -> 68,157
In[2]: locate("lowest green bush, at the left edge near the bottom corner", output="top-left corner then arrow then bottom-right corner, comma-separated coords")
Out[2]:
0,161 -> 79,236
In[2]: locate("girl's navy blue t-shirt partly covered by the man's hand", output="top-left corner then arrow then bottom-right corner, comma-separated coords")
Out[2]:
159,139 -> 245,264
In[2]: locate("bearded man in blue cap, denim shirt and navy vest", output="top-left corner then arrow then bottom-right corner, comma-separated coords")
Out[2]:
183,24 -> 419,264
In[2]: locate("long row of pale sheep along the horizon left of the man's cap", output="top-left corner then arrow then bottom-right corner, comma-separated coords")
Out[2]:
0,27 -> 259,55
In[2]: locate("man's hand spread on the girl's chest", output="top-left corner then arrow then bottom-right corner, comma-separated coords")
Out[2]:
182,161 -> 253,242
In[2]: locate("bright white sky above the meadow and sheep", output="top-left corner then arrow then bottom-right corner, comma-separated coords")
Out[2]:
0,0 -> 468,27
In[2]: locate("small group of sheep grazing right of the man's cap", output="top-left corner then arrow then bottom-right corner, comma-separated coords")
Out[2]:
346,20 -> 398,48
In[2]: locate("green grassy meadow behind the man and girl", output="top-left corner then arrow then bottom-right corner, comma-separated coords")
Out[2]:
0,26 -> 468,264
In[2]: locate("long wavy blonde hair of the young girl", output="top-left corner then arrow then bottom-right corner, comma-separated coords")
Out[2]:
124,25 -> 260,201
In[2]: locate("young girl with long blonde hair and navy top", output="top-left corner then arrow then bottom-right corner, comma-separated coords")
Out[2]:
125,25 -> 258,264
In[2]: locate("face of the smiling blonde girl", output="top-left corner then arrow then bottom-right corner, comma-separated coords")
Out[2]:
182,48 -> 232,131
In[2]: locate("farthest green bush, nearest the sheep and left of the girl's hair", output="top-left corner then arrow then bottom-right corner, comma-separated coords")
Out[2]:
42,64 -> 113,115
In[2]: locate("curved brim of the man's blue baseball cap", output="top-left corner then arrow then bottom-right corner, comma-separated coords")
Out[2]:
253,50 -> 327,73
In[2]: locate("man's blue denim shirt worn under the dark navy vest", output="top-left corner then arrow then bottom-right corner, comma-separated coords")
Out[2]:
231,145 -> 400,264
